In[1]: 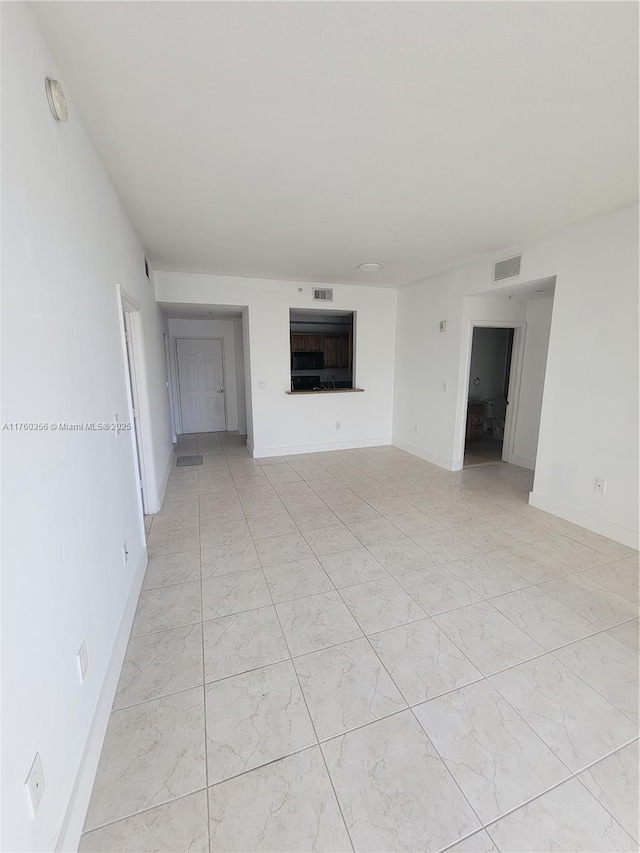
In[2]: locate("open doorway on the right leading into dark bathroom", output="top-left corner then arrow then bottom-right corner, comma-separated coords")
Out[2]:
463,323 -> 524,468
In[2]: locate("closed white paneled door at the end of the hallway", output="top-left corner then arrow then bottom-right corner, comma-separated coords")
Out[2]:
176,338 -> 226,432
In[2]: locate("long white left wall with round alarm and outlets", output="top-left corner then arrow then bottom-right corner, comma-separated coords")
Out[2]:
0,3 -> 171,851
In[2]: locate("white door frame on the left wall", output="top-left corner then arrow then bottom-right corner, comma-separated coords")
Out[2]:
116,284 -> 158,516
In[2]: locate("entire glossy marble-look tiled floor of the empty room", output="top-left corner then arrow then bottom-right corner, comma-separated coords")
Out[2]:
81,434 -> 639,853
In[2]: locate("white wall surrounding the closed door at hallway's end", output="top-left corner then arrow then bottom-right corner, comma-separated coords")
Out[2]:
169,319 -> 246,435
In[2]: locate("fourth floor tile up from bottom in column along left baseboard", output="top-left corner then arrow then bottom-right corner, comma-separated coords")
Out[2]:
131,581 -> 202,637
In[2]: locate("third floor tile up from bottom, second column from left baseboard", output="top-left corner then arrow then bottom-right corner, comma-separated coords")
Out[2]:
203,606 -> 289,681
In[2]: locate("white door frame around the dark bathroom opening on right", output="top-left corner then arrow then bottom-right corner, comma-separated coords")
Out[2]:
454,320 -> 527,468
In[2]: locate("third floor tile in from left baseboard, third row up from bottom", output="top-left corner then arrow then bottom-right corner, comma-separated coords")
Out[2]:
276,592 -> 362,655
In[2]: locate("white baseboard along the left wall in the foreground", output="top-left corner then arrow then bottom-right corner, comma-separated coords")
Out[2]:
55,545 -> 147,853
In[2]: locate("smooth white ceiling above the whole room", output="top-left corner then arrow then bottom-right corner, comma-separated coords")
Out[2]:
32,0 -> 638,286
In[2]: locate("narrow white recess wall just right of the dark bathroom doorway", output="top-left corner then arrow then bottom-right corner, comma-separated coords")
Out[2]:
512,296 -> 553,470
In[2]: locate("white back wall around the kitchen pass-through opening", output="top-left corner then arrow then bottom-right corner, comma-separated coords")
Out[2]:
155,272 -> 396,456
